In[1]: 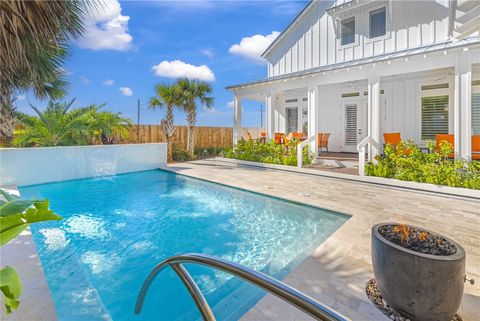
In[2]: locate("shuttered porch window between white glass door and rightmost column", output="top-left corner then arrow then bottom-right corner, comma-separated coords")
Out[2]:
422,95 -> 448,140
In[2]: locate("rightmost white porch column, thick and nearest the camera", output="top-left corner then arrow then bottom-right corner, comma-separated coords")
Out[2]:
453,52 -> 472,160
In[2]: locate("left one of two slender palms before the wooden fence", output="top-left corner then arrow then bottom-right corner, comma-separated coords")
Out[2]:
148,84 -> 181,162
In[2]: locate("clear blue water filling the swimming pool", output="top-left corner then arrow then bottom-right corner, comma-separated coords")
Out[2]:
20,170 -> 348,321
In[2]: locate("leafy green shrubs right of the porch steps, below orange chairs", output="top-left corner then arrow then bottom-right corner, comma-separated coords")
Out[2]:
365,141 -> 480,189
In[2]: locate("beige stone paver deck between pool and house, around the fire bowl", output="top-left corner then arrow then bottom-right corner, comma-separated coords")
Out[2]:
164,160 -> 480,321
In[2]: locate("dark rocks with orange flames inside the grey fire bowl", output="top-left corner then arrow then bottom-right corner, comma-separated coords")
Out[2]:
378,225 -> 457,256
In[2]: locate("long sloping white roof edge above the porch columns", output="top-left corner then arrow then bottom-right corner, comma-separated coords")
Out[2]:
226,37 -> 480,91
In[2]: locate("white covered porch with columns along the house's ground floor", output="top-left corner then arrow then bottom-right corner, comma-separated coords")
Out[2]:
228,39 -> 480,174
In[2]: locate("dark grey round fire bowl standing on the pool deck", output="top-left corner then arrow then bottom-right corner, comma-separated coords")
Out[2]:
372,223 -> 465,321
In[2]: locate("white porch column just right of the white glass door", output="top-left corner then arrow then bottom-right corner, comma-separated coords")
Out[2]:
367,75 -> 382,161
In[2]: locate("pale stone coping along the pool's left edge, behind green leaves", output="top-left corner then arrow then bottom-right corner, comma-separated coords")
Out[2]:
0,186 -> 58,321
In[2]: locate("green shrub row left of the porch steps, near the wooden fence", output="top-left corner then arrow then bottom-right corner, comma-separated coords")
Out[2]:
223,139 -> 312,166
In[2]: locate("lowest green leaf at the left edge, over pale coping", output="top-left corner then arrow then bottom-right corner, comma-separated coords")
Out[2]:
0,266 -> 22,314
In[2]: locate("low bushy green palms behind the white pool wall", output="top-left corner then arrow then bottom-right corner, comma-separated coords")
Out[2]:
13,100 -> 130,147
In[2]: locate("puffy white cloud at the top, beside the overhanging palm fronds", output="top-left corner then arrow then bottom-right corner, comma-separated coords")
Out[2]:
78,0 -> 133,51
